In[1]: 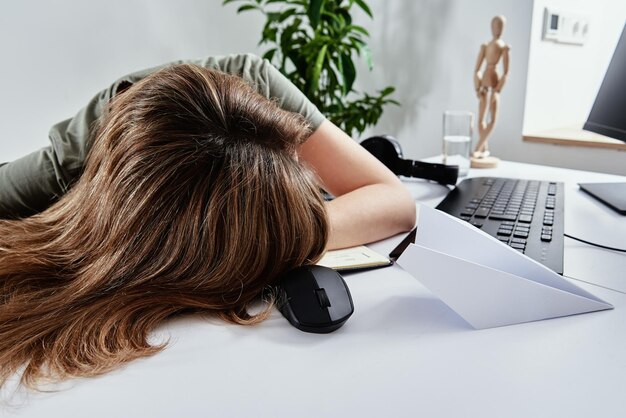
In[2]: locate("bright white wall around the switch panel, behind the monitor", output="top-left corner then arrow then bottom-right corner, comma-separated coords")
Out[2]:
524,0 -> 626,132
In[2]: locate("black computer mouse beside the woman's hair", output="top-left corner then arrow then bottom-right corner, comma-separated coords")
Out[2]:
276,266 -> 354,334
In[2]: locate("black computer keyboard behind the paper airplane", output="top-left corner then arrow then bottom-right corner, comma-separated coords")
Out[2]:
437,177 -> 565,274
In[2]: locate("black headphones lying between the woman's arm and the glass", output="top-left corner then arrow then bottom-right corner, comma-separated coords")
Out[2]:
361,135 -> 459,184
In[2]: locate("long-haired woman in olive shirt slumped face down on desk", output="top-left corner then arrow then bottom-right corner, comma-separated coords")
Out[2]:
0,55 -> 415,386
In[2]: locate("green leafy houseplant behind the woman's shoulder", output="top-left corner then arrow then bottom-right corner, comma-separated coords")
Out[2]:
223,0 -> 398,135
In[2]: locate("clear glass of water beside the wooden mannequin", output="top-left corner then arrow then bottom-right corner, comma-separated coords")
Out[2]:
443,110 -> 474,176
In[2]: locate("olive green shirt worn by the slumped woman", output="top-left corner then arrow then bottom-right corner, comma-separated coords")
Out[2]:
0,54 -> 324,219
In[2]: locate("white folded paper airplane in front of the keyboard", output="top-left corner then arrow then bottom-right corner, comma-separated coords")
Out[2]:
398,205 -> 613,329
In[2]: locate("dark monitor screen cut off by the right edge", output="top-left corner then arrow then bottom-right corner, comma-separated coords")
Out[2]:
583,25 -> 626,142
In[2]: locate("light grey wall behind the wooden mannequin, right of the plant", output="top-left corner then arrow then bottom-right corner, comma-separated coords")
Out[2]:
354,0 -> 532,164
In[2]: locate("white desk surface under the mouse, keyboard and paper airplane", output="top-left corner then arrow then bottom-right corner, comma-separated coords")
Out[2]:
0,163 -> 626,418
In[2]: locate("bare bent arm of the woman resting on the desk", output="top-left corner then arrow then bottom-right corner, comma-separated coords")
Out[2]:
299,120 -> 415,249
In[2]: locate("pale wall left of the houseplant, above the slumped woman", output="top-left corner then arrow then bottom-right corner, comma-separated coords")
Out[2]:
0,0 -> 262,162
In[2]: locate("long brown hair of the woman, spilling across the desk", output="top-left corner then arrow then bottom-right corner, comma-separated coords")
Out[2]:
0,65 -> 328,387
